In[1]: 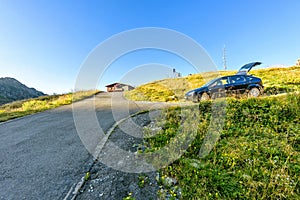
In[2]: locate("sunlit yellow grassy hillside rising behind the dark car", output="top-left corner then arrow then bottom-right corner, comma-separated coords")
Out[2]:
126,67 -> 300,101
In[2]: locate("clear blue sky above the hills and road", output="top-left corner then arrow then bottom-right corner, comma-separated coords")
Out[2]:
0,0 -> 300,94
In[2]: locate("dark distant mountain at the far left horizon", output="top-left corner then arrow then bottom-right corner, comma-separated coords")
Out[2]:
0,78 -> 45,105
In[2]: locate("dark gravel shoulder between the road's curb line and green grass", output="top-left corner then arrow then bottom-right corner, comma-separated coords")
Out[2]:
76,110 -> 161,200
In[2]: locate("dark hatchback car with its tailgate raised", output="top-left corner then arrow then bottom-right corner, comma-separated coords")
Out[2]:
185,62 -> 264,102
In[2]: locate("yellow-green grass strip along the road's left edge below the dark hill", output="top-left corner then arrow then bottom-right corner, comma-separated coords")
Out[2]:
0,90 -> 99,122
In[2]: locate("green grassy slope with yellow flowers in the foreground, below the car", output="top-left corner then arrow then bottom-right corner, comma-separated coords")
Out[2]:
145,93 -> 300,199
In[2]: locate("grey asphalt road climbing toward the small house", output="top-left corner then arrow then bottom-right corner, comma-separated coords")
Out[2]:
0,93 -> 164,200
